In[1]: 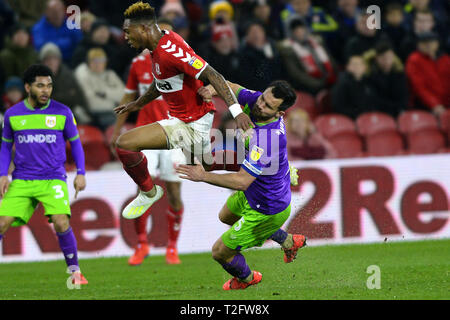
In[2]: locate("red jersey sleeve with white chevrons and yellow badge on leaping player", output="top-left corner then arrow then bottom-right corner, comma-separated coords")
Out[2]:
162,36 -> 208,79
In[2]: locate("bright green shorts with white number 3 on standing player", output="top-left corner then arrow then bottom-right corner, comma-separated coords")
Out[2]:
0,179 -> 70,227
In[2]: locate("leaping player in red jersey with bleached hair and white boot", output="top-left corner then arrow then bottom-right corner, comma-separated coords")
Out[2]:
114,2 -> 253,219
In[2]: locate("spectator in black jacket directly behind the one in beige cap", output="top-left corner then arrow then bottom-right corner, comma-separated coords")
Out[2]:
70,18 -> 131,76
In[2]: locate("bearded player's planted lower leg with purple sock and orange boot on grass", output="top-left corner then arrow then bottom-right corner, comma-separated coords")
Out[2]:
212,238 -> 262,290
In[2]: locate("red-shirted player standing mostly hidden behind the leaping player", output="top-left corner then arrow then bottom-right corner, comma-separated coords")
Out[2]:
111,20 -> 186,266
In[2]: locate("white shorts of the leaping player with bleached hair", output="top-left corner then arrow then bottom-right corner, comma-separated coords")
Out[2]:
158,112 -> 214,156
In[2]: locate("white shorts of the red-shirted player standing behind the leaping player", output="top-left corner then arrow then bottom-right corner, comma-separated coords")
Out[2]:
142,149 -> 186,182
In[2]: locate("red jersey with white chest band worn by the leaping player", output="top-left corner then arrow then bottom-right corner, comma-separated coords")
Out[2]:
151,30 -> 215,122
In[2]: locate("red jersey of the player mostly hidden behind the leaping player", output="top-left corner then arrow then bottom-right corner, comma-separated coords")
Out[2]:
125,54 -> 169,127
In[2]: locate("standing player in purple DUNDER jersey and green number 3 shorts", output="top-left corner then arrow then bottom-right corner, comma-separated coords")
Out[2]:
0,65 -> 88,285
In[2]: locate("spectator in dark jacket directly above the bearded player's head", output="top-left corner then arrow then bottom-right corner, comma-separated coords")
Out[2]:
239,21 -> 283,90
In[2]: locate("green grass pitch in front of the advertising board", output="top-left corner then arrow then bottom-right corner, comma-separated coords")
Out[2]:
0,240 -> 450,300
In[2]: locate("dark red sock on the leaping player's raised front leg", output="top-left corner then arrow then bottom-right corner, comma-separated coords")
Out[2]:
116,148 -> 154,192
